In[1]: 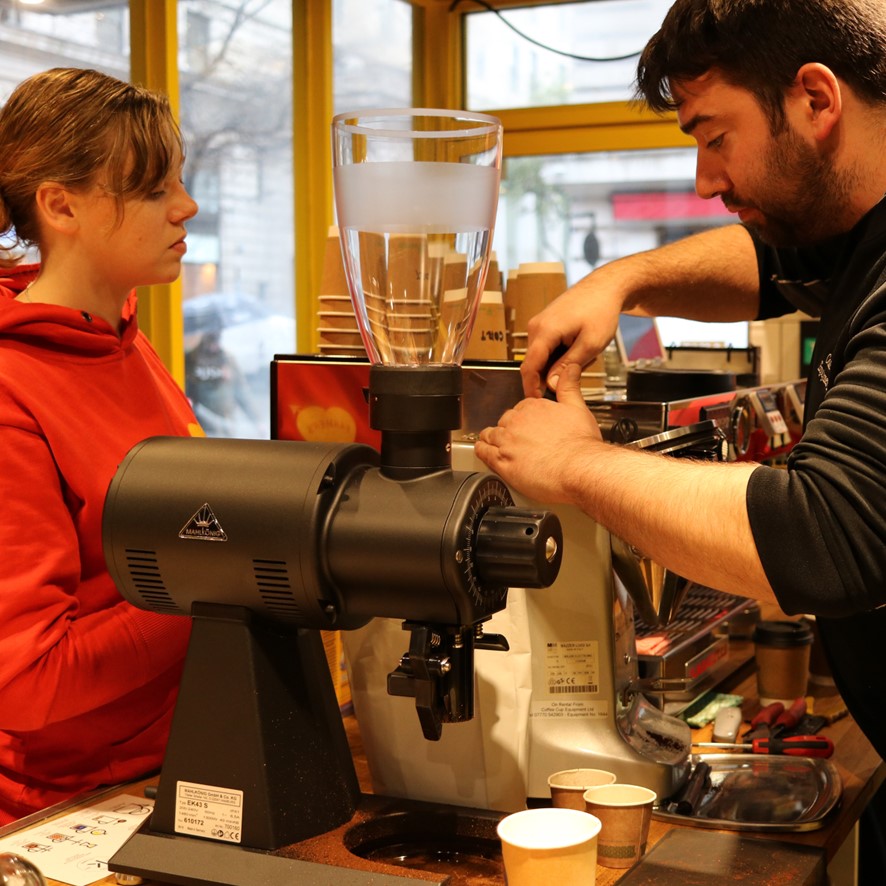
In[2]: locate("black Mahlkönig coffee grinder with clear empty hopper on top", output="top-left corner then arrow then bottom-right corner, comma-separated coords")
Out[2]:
103,110 -> 562,886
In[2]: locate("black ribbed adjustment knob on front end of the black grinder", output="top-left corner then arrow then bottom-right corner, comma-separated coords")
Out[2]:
474,507 -> 563,588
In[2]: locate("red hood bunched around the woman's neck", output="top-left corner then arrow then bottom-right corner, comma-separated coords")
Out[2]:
0,264 -> 138,359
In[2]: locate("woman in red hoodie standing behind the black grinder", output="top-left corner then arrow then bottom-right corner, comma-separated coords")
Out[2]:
0,69 -> 202,824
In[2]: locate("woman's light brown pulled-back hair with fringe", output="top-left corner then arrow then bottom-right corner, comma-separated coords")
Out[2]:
0,68 -> 184,263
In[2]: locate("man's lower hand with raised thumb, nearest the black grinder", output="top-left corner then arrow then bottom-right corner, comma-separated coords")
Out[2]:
475,363 -> 601,504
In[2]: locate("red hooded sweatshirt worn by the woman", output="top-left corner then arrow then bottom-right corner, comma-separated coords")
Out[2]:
0,265 -> 202,824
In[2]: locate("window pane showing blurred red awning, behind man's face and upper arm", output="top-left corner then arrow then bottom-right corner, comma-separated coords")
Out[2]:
493,148 -> 748,347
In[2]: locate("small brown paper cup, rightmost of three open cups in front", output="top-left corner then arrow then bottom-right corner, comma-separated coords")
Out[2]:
584,784 -> 656,868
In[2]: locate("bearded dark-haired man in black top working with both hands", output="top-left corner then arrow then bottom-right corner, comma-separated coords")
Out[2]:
476,0 -> 886,882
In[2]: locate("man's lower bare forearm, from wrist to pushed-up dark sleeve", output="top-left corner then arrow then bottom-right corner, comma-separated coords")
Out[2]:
567,441 -> 775,602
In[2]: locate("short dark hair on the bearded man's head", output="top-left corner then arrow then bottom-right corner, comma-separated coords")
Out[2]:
636,0 -> 886,131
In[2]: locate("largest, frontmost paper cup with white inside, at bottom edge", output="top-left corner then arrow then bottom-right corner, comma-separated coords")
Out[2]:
498,808 -> 600,886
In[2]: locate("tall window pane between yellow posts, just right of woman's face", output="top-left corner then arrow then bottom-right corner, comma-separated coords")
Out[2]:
178,0 -> 296,438
